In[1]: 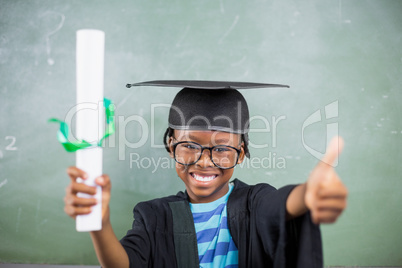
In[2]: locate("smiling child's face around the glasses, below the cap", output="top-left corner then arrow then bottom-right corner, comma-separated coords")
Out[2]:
169,130 -> 244,203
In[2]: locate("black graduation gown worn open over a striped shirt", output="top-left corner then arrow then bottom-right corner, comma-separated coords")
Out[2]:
121,179 -> 323,268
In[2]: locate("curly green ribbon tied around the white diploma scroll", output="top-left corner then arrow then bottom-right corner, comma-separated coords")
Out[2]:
48,98 -> 115,152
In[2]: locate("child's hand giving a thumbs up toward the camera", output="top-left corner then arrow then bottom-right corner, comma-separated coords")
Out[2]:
304,137 -> 348,224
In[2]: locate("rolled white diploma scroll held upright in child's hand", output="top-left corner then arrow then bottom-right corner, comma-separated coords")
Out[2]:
76,29 -> 105,232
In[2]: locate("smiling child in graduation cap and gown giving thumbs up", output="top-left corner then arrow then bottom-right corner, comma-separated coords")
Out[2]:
65,81 -> 347,268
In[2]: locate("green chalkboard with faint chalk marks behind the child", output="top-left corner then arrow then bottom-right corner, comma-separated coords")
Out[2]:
0,0 -> 402,266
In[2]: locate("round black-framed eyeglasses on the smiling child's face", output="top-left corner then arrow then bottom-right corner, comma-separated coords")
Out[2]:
173,141 -> 241,169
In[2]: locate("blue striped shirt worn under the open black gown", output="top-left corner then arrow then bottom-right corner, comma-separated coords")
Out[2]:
190,184 -> 238,268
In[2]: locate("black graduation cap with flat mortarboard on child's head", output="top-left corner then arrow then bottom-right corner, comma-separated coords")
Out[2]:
126,80 -> 289,134
